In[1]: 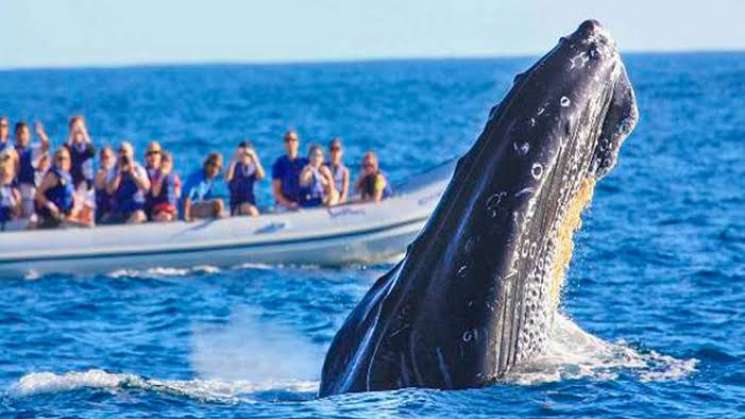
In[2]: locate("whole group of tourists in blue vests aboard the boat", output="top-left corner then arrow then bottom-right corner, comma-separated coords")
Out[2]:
0,116 -> 392,228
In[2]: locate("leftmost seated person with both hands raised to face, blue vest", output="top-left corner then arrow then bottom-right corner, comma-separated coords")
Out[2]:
105,141 -> 150,224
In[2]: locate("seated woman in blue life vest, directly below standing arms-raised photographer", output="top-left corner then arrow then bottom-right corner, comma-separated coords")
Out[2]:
36,147 -> 88,228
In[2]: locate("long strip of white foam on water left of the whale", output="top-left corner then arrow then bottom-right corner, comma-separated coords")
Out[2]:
12,369 -> 319,402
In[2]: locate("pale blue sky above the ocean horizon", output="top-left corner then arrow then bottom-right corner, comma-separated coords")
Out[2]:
0,0 -> 745,68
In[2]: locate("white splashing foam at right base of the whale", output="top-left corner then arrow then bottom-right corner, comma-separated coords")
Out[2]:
506,315 -> 698,385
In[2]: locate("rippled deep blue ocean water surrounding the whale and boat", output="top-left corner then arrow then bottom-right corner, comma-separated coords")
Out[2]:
0,53 -> 745,418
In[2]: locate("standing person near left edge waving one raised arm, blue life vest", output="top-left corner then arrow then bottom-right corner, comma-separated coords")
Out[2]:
15,122 -> 49,222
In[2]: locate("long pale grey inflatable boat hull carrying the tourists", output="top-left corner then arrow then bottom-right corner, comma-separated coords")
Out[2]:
0,162 -> 455,275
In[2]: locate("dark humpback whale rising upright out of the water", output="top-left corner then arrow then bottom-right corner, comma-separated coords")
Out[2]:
319,20 -> 638,396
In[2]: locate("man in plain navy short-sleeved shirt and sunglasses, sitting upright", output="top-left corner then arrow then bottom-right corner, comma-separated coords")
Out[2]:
272,130 -> 308,210
